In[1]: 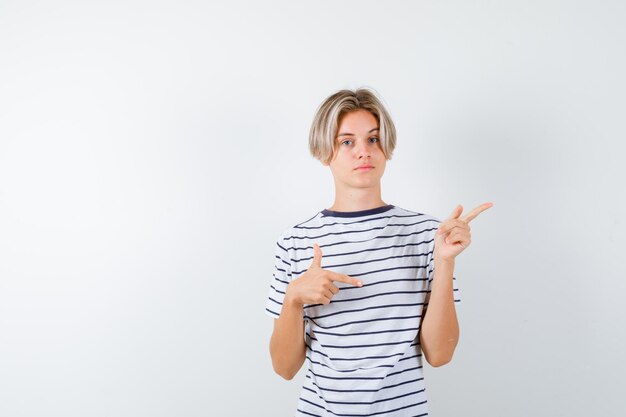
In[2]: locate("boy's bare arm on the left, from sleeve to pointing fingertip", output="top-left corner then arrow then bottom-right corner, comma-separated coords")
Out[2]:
270,243 -> 363,380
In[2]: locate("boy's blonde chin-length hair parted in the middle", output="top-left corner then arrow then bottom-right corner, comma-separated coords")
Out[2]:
309,88 -> 396,165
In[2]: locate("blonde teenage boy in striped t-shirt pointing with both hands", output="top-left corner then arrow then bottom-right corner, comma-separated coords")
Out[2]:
266,89 -> 492,416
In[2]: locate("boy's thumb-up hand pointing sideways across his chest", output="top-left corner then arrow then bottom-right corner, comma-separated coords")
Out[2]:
285,243 -> 363,305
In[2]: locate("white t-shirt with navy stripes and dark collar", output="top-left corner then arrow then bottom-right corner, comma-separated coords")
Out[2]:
266,205 -> 460,417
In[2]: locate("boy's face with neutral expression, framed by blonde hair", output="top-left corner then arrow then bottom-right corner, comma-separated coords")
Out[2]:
328,109 -> 387,189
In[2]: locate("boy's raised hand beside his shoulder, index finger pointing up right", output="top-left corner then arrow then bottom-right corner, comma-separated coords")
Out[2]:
435,203 -> 493,261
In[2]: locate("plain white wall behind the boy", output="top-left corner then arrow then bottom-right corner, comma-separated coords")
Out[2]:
0,0 -> 626,417
